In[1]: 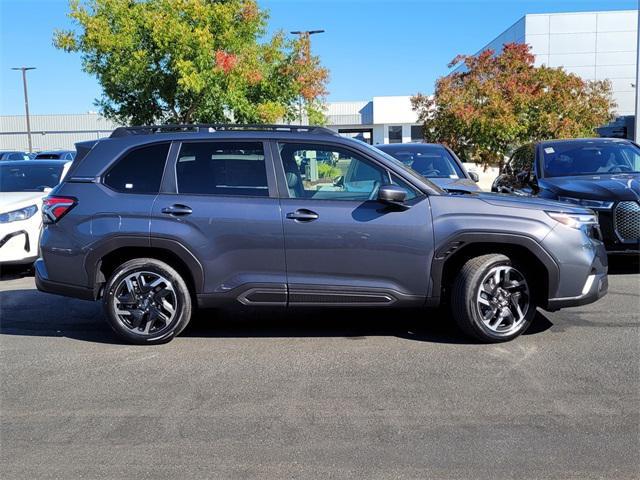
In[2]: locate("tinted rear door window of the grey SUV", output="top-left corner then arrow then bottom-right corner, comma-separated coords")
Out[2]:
176,142 -> 269,197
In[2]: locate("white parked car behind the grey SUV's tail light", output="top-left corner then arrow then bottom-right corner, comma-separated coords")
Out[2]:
0,160 -> 71,264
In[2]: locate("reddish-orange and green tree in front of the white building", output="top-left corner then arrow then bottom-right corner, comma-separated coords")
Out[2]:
412,43 -> 615,166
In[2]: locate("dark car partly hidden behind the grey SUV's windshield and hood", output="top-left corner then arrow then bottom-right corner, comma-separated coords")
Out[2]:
376,143 -> 480,192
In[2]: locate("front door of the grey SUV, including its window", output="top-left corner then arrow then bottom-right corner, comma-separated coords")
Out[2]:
272,142 -> 433,305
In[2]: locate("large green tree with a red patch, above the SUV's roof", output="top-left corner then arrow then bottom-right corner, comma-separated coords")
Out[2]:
53,0 -> 328,124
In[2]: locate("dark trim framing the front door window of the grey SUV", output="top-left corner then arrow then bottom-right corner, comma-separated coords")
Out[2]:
270,138 -> 427,203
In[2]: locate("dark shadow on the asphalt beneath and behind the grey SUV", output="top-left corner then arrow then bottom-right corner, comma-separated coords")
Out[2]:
0,290 -> 553,345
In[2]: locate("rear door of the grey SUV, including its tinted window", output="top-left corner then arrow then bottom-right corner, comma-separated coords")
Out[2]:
151,140 -> 286,305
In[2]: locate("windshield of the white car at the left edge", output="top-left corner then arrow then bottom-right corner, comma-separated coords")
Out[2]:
0,165 -> 64,192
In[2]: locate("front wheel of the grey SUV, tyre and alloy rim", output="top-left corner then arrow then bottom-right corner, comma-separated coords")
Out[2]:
451,254 -> 536,343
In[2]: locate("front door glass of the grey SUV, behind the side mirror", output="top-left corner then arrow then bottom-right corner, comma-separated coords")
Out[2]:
279,143 -> 389,201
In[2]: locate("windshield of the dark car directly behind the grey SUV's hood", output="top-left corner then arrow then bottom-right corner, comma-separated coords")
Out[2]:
382,145 -> 465,179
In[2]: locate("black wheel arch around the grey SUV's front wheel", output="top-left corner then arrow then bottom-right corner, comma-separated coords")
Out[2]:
430,232 -> 560,306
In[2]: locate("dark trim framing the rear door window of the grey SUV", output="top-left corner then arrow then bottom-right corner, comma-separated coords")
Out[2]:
167,138 -> 278,199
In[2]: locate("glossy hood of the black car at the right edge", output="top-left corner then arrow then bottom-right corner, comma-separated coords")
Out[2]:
540,173 -> 640,201
